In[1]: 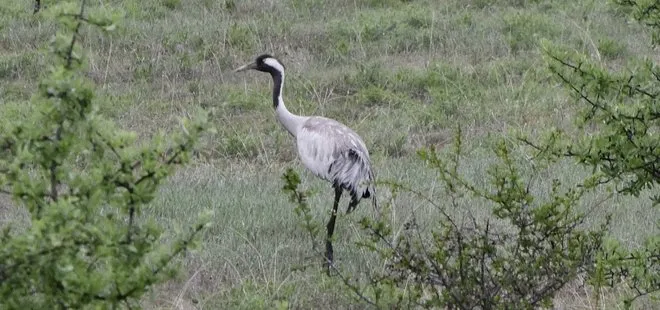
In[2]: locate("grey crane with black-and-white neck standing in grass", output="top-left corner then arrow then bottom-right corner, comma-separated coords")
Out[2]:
234,54 -> 378,275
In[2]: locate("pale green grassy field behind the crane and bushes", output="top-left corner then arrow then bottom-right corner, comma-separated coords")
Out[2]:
0,0 -> 660,309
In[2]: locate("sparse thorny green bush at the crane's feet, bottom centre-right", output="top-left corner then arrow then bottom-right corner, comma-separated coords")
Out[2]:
285,132 -> 608,309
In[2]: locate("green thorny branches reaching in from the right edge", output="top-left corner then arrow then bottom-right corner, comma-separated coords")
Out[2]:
522,0 -> 660,306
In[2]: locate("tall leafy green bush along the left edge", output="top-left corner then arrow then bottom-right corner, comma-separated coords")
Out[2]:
0,1 -> 208,309
